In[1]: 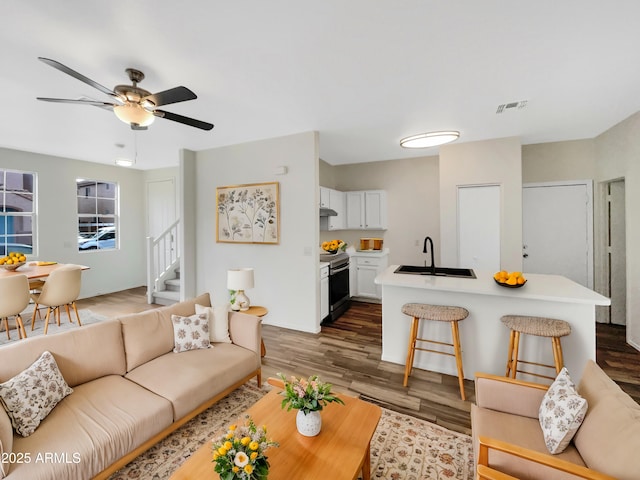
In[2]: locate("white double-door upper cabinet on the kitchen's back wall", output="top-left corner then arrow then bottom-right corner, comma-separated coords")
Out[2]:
344,190 -> 387,230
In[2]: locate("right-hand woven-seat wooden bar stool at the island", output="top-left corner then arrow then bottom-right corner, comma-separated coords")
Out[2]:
501,315 -> 571,380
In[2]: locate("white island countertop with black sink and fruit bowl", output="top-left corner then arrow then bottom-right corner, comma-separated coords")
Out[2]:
375,265 -> 611,305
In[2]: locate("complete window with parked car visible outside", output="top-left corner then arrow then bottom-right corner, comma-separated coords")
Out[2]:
76,179 -> 118,252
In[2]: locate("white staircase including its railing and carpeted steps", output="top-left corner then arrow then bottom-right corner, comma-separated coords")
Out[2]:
147,220 -> 181,305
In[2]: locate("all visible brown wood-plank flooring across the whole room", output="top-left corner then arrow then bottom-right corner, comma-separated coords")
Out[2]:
77,287 -> 640,434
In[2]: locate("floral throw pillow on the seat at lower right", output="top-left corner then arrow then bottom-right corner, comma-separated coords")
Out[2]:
538,368 -> 588,454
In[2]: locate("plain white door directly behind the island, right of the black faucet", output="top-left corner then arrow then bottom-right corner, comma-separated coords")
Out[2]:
458,185 -> 500,272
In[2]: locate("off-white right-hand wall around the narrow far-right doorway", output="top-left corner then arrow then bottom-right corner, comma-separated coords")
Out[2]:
595,112 -> 640,350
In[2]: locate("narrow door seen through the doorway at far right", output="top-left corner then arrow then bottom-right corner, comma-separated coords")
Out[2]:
608,180 -> 627,325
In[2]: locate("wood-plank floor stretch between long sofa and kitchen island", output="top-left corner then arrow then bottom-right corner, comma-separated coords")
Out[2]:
262,302 -> 474,433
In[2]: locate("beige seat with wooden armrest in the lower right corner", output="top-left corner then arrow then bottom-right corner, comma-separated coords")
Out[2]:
471,361 -> 640,480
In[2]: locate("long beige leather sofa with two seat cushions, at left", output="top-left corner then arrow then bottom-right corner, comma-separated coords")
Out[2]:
0,294 -> 261,480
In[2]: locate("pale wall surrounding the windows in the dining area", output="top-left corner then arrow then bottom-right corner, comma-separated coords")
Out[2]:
0,148 -> 146,298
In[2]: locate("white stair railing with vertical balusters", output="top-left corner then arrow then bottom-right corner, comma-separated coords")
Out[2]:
147,219 -> 181,303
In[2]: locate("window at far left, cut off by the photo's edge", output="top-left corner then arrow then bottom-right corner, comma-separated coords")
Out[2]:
0,170 -> 36,256
